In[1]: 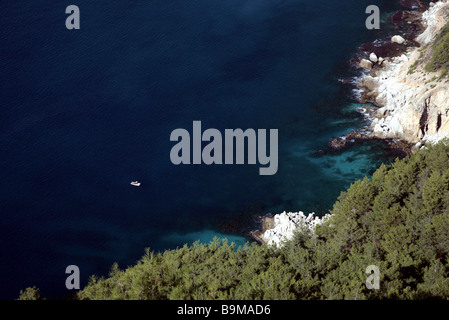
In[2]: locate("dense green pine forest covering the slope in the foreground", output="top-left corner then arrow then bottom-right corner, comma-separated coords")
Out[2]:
19,140 -> 449,300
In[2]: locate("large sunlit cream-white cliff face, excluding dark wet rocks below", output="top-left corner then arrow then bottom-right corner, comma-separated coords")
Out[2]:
358,0 -> 449,144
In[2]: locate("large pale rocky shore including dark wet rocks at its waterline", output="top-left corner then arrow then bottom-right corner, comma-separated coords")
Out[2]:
326,0 -> 449,155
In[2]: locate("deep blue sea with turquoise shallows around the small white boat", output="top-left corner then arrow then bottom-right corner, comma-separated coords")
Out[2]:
0,0 -> 399,299
